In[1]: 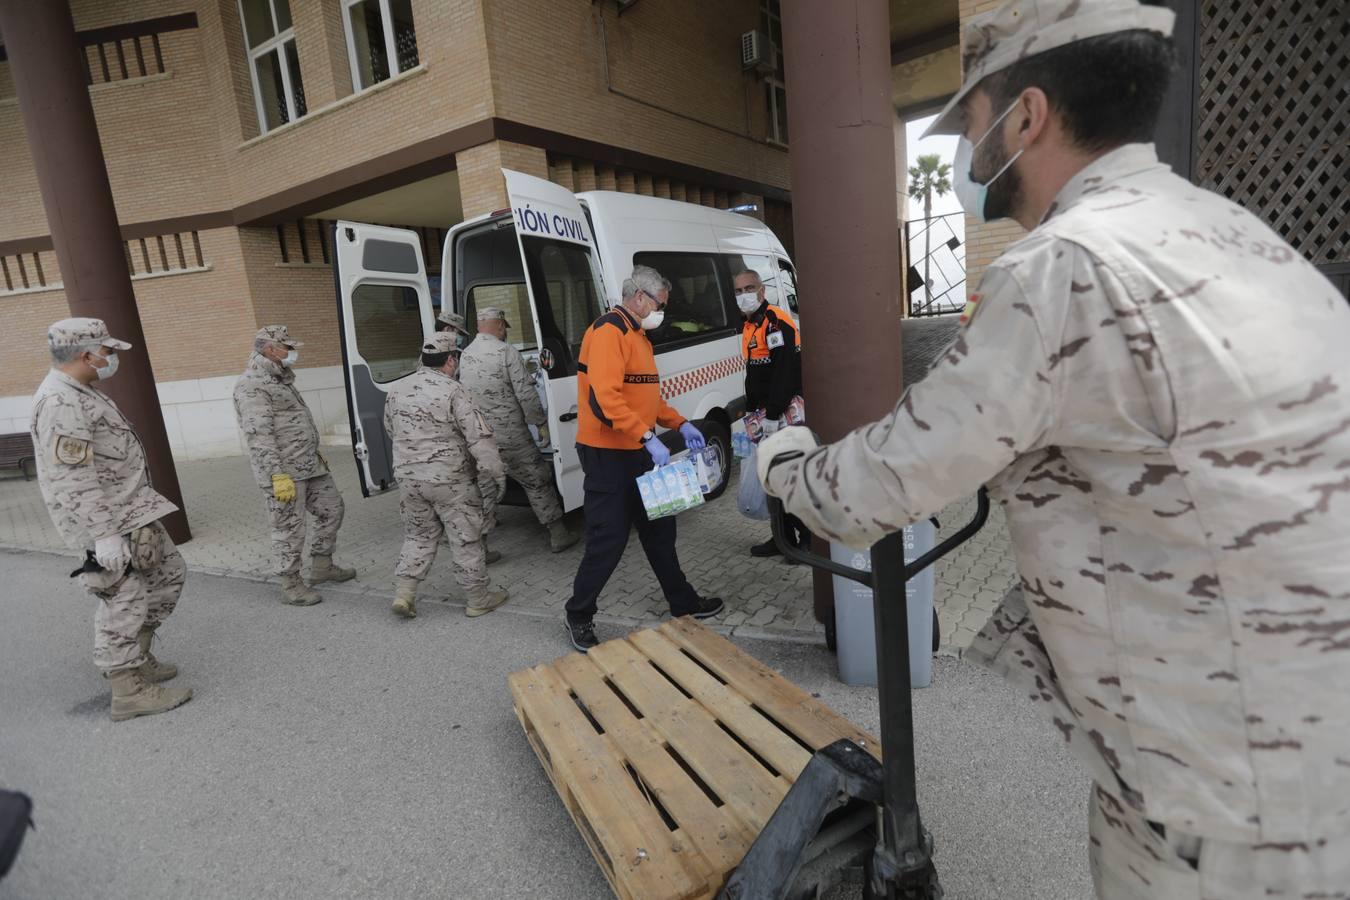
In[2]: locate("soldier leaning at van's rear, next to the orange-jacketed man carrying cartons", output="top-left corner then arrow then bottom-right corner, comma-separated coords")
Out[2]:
459,306 -> 581,553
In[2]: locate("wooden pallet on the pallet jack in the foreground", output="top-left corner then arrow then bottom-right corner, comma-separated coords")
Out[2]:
509,619 -> 879,900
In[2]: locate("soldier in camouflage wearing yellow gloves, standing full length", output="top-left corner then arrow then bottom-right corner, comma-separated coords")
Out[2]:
235,325 -> 356,606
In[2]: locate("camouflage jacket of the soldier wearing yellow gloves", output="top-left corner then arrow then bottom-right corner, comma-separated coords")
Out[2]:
235,352 -> 328,490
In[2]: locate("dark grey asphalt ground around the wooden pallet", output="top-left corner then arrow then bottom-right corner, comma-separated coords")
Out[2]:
0,553 -> 1091,900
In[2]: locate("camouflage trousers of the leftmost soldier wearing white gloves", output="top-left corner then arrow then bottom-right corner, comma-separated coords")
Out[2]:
80,522 -> 188,672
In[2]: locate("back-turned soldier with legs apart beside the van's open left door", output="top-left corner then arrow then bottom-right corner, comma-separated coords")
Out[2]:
385,331 -> 506,618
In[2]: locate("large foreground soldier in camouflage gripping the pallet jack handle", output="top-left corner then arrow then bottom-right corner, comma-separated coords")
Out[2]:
760,0 -> 1350,900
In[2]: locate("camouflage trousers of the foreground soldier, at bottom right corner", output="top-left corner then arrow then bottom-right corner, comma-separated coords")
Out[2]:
1088,785 -> 1350,900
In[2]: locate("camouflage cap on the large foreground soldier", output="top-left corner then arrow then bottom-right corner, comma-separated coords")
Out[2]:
922,0 -> 1176,138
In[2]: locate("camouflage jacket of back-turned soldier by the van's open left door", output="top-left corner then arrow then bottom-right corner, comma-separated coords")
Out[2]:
385,366 -> 505,484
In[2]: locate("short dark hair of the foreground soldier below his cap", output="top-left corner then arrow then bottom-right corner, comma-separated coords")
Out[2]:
980,30 -> 1176,151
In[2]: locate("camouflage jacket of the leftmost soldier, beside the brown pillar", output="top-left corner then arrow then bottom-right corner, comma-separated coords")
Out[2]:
30,368 -> 178,549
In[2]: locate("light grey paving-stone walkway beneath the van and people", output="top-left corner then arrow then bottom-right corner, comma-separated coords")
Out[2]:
0,448 -> 1013,650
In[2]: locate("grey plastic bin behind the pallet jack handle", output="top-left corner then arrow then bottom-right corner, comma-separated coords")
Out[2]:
830,519 -> 937,688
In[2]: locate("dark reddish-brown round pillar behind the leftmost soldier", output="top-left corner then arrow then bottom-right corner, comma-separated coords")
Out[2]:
0,0 -> 192,544
